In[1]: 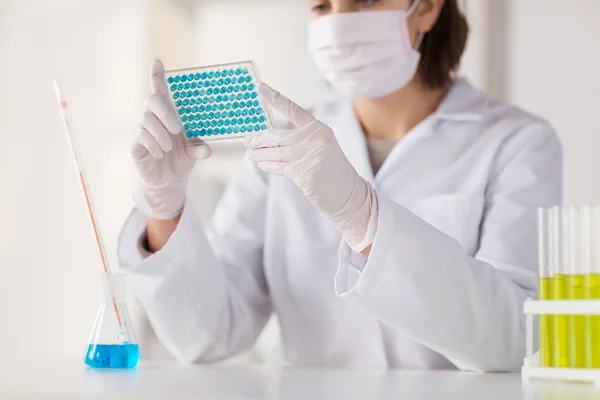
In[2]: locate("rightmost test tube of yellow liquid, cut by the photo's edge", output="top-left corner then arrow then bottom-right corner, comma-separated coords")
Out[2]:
585,207 -> 600,368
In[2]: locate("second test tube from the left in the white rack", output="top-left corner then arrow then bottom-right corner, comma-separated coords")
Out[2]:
551,206 -> 570,368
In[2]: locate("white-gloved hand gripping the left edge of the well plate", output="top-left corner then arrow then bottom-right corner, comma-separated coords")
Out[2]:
130,60 -> 212,220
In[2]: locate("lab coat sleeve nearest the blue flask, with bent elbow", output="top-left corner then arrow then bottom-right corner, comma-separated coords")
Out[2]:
118,162 -> 271,362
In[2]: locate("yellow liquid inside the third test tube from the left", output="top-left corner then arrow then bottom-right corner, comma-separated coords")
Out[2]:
567,275 -> 587,368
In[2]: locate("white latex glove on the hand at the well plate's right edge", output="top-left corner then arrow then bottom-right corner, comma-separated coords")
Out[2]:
246,84 -> 378,252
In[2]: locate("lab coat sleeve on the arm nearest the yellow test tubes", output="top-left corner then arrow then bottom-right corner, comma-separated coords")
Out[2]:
335,123 -> 562,371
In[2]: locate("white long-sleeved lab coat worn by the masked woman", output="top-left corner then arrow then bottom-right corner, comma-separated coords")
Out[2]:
119,80 -> 561,371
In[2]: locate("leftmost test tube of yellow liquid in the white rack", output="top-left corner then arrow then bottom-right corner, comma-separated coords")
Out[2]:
538,208 -> 554,367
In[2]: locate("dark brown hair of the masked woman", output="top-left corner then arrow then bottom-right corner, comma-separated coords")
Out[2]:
413,0 -> 469,89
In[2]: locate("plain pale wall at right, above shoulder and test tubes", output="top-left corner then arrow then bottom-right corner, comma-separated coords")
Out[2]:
506,0 -> 600,204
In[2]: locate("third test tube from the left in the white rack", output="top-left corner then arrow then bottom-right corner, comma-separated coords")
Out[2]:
567,206 -> 587,368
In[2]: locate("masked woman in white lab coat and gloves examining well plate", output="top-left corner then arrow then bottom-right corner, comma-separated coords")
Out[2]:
119,0 -> 561,371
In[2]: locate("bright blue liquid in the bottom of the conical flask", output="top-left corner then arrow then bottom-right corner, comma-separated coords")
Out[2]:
85,344 -> 140,368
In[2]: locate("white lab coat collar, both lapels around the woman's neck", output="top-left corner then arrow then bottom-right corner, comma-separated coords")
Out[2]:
334,79 -> 488,184
